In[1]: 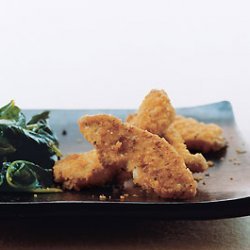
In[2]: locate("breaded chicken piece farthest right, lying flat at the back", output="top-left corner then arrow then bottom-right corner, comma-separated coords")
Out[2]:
173,116 -> 226,153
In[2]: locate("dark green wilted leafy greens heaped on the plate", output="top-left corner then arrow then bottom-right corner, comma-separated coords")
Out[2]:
0,101 -> 61,191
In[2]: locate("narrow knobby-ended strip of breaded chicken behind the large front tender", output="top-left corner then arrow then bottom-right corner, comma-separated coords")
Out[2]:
164,125 -> 208,172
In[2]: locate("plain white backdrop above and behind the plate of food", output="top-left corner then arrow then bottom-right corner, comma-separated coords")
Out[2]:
0,0 -> 250,137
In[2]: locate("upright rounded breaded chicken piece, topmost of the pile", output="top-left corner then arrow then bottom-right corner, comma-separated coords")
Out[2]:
127,90 -> 175,137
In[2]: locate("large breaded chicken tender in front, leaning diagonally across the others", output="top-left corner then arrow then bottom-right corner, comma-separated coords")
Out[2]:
79,115 -> 197,199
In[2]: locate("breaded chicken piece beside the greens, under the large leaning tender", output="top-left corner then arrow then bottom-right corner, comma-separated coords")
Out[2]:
53,150 -> 116,191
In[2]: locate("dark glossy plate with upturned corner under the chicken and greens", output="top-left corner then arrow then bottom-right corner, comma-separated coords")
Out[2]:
0,102 -> 250,219
